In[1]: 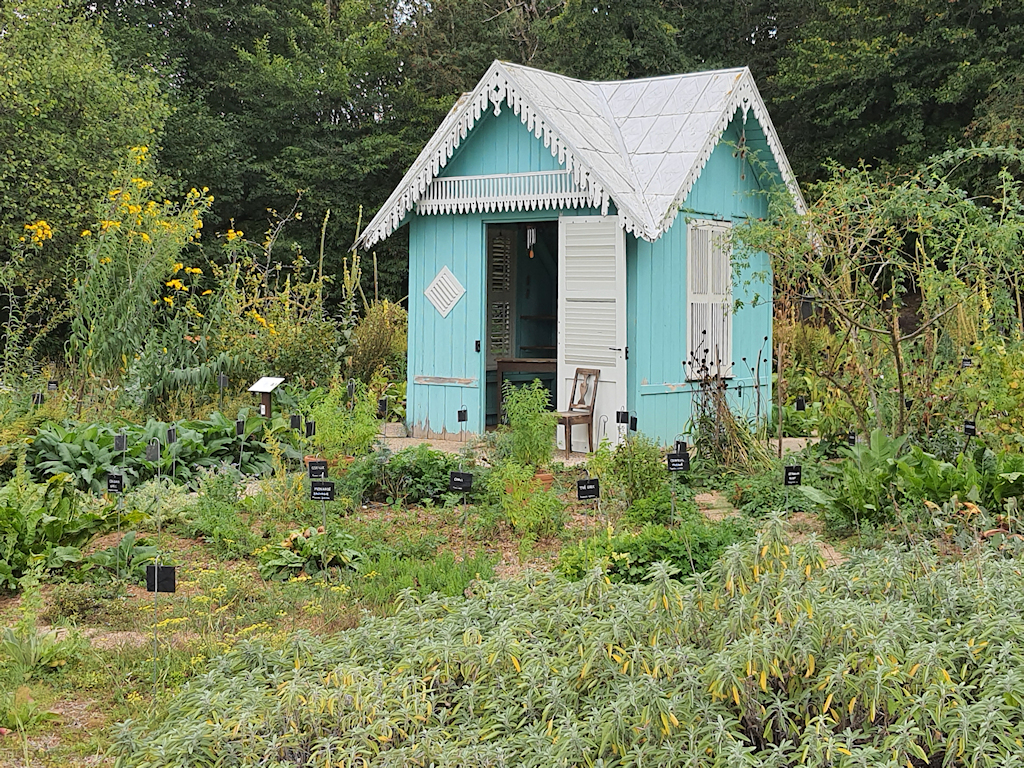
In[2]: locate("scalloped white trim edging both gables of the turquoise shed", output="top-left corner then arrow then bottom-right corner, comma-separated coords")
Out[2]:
356,61 -> 806,248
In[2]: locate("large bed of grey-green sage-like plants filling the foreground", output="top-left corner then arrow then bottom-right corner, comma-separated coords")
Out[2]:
108,517 -> 1024,768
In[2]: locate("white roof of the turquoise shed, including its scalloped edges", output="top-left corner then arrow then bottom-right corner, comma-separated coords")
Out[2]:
359,61 -> 805,247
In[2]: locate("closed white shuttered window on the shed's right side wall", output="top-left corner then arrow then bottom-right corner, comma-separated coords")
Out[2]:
686,220 -> 732,379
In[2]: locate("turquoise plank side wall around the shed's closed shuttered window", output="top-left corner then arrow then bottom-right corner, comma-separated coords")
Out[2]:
626,115 -> 772,444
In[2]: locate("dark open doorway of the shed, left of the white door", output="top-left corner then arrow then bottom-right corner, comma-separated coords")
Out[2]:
484,221 -> 558,426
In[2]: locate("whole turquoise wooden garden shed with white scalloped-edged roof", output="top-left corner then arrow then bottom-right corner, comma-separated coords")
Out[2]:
359,61 -> 804,445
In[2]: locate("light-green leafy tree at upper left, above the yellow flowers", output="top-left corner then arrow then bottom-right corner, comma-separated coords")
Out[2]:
0,0 -> 167,284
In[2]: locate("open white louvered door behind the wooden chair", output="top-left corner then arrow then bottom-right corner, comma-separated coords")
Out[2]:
557,216 -> 626,451
